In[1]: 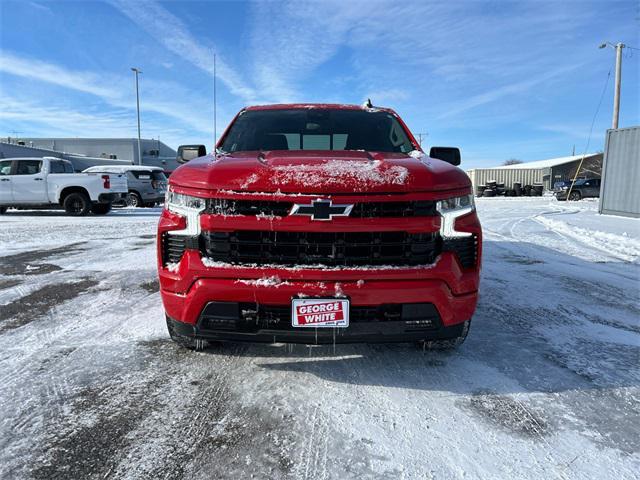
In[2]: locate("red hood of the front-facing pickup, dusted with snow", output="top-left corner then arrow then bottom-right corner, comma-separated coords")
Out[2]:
169,150 -> 471,194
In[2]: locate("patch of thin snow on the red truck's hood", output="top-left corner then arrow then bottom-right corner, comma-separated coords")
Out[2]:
272,160 -> 409,187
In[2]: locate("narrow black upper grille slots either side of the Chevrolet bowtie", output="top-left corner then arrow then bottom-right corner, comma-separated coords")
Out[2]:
205,198 -> 437,218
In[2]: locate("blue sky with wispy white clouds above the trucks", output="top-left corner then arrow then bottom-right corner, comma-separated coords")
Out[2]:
0,0 -> 640,168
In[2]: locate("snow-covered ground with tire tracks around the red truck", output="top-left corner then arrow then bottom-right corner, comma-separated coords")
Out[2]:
0,198 -> 640,479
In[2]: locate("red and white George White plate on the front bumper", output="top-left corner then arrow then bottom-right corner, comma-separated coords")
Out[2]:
291,297 -> 350,328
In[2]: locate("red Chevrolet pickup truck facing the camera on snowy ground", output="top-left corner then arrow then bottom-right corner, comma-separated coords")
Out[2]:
158,104 -> 482,349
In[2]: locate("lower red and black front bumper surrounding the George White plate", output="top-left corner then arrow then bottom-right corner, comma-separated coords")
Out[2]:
161,272 -> 478,343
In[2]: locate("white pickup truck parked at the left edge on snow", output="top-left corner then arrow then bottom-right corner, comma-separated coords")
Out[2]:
0,157 -> 128,215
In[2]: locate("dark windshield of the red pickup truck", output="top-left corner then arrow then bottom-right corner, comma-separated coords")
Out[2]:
221,108 -> 414,153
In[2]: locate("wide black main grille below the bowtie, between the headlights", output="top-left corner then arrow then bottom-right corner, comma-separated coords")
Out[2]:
201,230 -> 440,267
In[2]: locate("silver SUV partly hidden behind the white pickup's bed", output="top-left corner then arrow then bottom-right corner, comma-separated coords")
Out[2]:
85,165 -> 167,207
